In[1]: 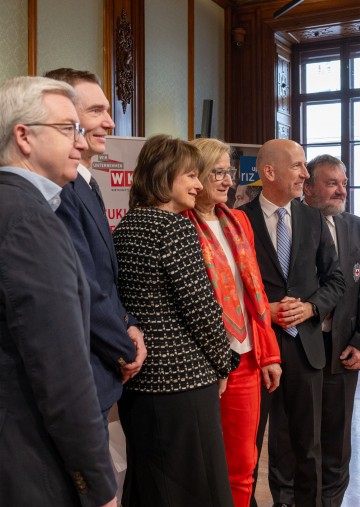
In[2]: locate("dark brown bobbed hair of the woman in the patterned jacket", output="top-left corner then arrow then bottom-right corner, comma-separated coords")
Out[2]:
129,134 -> 203,209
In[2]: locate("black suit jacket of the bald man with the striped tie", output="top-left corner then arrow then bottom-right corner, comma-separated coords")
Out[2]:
240,197 -> 345,369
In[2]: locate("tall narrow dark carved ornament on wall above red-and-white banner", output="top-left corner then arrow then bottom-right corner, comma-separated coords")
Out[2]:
115,9 -> 134,114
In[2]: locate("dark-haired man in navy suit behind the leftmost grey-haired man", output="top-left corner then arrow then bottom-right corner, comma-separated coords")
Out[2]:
46,68 -> 146,427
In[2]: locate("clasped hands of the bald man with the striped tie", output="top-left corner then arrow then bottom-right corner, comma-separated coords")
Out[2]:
270,296 -> 313,329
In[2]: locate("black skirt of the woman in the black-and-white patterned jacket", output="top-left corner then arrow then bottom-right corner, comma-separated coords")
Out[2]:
119,384 -> 234,507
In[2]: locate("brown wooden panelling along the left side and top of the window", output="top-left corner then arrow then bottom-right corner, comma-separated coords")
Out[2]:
229,0 -> 360,144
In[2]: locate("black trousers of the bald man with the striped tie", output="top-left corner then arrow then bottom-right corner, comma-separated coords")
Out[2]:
251,331 -> 323,507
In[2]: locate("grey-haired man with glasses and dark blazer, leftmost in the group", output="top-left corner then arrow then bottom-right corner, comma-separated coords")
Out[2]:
0,77 -> 116,507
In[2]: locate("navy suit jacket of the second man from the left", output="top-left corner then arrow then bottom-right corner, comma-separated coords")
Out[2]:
56,174 -> 137,410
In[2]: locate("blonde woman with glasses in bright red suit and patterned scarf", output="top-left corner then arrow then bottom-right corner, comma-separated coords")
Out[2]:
185,139 -> 281,507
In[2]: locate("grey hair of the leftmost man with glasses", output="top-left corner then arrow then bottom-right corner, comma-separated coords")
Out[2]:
0,76 -> 76,166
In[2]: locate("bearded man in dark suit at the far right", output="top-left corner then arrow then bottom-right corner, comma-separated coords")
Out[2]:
269,155 -> 360,507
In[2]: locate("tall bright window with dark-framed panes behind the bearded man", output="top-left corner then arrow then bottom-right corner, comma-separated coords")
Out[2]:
293,39 -> 360,216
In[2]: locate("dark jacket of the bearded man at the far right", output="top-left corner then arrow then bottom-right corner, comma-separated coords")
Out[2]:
331,213 -> 360,373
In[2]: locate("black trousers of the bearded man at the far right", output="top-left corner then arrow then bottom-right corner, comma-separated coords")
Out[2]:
269,346 -> 358,507
